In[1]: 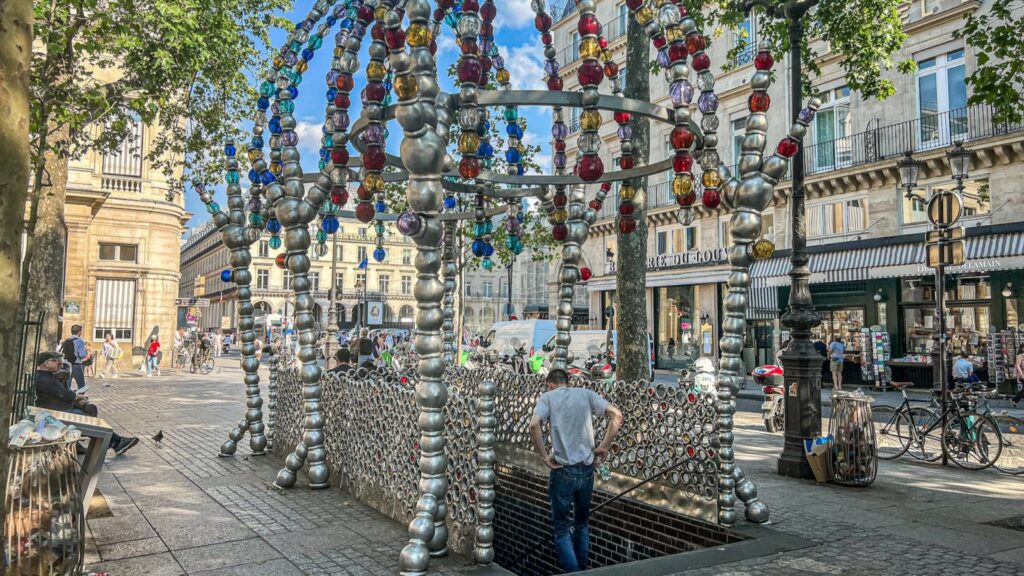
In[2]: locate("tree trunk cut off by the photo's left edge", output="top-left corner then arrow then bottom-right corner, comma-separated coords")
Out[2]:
0,0 -> 33,528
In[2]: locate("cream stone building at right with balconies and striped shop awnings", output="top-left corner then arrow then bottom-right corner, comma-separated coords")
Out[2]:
552,0 -> 1024,375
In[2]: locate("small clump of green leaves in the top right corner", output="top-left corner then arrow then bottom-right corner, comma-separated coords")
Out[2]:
953,0 -> 1024,123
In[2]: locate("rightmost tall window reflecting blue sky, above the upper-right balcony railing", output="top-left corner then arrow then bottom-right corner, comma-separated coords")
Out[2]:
918,48 -> 968,148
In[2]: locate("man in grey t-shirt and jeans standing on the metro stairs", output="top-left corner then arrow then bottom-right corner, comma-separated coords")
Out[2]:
529,370 -> 623,573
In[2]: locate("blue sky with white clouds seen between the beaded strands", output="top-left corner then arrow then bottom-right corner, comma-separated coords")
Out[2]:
185,0 -> 551,228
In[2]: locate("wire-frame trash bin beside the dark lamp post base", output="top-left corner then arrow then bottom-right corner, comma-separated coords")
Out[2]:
828,389 -> 879,486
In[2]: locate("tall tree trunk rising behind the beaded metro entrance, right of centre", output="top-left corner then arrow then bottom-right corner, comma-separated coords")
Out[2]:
614,18 -> 650,381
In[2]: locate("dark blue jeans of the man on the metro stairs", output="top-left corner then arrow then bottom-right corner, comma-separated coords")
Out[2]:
548,464 -> 594,573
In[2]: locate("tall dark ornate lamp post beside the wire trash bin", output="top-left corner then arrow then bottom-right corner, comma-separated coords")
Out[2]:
743,0 -> 823,478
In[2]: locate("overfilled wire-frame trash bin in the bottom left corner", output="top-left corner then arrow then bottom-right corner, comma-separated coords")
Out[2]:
4,430 -> 85,576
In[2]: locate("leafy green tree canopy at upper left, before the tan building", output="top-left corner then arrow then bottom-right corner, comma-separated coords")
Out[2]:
32,0 -> 290,189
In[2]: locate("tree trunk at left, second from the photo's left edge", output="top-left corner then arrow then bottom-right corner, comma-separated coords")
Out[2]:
25,125 -> 68,349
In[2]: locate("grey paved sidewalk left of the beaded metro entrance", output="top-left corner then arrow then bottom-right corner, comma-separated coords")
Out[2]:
80,358 -> 472,576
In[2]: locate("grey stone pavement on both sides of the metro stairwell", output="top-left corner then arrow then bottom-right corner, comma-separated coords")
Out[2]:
81,359 -> 1024,576
